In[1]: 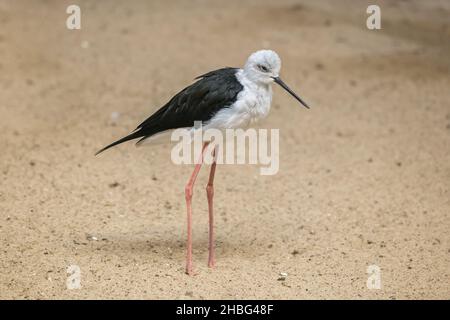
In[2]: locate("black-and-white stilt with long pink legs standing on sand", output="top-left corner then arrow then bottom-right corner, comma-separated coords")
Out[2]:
96,49 -> 309,275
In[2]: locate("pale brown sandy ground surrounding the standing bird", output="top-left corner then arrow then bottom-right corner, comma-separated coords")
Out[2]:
0,0 -> 450,299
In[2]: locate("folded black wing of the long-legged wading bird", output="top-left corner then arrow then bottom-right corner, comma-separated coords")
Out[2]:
96,68 -> 243,154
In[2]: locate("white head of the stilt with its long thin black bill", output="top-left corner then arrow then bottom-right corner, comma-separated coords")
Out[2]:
244,50 -> 309,109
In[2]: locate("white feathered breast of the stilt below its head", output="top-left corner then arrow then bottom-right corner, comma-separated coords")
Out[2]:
206,70 -> 272,129
